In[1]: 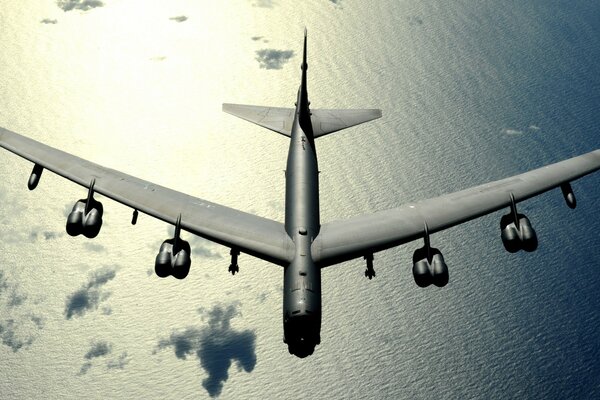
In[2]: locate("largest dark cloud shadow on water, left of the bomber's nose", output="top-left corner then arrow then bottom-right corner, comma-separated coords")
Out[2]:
158,302 -> 256,397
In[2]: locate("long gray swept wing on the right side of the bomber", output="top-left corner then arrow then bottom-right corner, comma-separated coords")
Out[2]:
312,150 -> 600,267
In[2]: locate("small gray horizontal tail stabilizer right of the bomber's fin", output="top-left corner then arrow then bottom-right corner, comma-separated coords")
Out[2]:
310,109 -> 381,138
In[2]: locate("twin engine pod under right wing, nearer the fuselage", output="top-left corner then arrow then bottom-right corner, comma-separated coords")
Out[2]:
413,246 -> 450,287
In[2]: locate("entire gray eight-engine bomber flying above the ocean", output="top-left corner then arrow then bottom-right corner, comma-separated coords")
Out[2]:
0,31 -> 600,357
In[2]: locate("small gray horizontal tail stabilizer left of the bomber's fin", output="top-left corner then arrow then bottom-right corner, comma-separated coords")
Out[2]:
223,103 -> 294,137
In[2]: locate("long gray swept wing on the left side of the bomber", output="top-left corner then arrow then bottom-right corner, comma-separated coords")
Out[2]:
0,128 -> 293,265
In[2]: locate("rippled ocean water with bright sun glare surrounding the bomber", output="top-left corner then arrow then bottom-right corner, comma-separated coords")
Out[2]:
0,0 -> 600,399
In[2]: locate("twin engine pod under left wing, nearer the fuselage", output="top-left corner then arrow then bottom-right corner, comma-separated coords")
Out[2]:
154,238 -> 192,279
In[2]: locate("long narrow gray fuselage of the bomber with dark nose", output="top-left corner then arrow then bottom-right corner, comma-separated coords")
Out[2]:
283,80 -> 321,357
